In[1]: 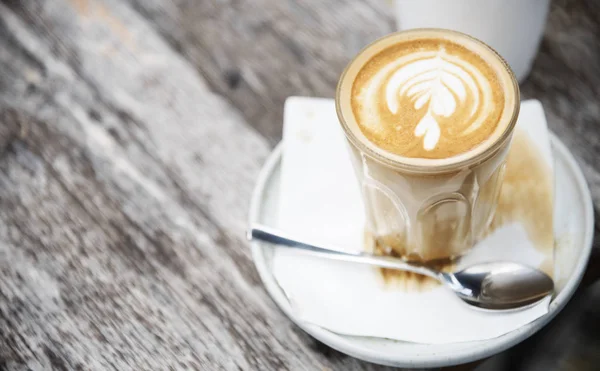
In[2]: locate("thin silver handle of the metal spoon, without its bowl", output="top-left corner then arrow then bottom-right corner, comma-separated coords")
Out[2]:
247,224 -> 440,279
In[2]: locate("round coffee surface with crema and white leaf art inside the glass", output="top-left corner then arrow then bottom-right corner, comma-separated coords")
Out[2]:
350,36 -> 507,159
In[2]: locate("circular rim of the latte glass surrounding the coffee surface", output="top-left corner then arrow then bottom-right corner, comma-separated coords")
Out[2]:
335,28 -> 520,174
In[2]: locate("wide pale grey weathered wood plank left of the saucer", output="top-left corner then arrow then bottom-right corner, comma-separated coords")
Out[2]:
0,1 -> 398,370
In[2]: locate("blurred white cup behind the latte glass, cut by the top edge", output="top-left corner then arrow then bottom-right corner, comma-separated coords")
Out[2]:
395,0 -> 550,82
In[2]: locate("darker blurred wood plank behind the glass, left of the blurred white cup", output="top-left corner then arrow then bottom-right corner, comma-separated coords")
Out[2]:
129,0 -> 393,145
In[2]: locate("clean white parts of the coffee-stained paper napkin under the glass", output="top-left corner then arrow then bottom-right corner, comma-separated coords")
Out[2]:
273,97 -> 552,344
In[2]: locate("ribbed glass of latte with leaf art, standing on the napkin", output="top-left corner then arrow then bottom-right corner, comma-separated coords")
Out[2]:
336,29 -> 519,263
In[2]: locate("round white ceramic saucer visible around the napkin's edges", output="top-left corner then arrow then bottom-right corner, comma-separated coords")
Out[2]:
250,133 -> 594,367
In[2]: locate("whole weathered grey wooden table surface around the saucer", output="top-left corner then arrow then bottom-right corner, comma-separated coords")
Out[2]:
0,0 -> 600,370
